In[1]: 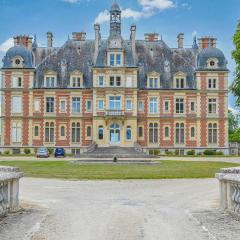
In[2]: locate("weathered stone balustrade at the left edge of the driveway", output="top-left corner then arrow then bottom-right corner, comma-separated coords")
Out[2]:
0,166 -> 23,217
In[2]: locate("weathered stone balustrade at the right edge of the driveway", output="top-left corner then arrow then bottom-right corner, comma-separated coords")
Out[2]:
216,167 -> 240,215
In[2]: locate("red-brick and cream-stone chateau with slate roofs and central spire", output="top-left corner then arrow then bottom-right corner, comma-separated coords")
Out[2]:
1,3 -> 228,154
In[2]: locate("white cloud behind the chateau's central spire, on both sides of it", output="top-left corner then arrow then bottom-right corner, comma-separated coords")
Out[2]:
94,0 -> 175,24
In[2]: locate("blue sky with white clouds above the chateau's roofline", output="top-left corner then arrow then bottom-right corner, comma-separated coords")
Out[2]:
0,0 -> 240,111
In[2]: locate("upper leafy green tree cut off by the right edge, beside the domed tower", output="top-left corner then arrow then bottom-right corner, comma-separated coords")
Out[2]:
231,21 -> 240,106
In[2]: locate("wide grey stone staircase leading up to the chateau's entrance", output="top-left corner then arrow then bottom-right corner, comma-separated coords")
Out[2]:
78,146 -> 154,159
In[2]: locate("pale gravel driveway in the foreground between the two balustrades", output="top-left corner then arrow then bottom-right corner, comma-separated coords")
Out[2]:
0,178 -> 240,240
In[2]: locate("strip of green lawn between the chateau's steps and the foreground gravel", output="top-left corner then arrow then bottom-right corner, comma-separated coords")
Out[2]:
0,161 -> 240,180
